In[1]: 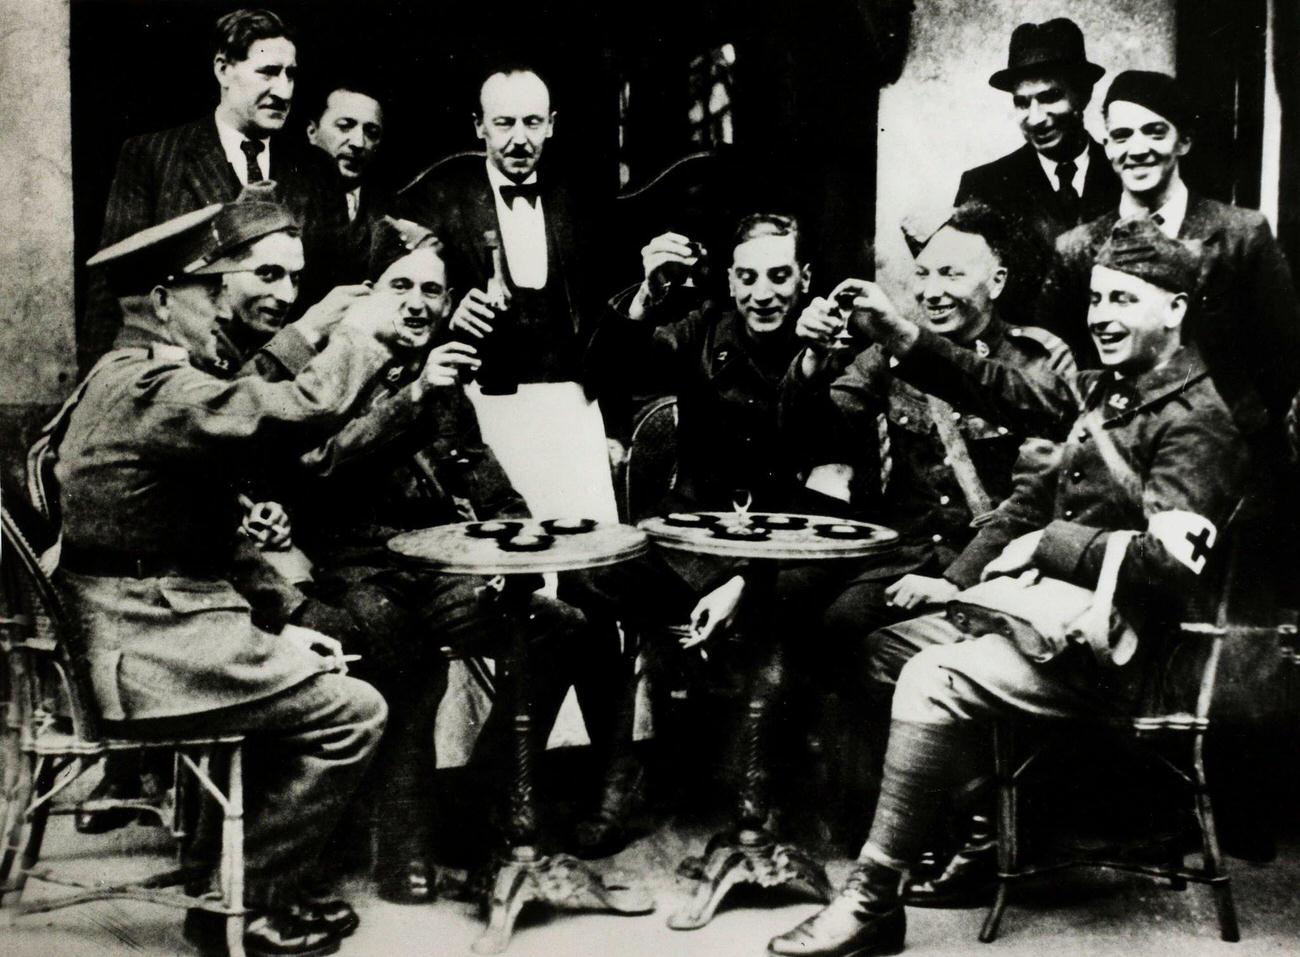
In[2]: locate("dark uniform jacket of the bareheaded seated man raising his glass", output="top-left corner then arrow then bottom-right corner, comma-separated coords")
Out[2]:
588,287 -> 798,511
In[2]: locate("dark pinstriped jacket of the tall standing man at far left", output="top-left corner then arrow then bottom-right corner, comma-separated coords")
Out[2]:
81,114 -> 325,369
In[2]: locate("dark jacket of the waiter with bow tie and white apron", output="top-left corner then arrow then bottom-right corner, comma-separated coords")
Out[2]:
397,153 -> 612,358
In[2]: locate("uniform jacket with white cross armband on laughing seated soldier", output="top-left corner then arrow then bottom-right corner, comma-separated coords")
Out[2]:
897,332 -> 1244,612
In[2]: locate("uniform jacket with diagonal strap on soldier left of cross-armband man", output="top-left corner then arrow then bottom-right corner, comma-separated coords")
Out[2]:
781,317 -> 1074,575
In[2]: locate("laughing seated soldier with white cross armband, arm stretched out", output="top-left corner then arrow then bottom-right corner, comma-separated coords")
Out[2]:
770,220 -> 1244,957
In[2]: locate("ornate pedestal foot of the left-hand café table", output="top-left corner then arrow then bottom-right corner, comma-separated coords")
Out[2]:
473,848 -> 654,953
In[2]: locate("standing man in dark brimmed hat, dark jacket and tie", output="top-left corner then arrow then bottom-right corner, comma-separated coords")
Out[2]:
954,18 -> 1119,321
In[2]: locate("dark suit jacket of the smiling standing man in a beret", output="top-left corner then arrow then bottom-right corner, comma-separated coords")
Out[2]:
1037,192 -> 1300,434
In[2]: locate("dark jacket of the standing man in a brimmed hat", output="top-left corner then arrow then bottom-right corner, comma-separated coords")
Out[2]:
954,139 -> 1119,330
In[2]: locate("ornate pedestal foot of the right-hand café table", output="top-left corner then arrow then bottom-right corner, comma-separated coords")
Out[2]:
668,828 -> 831,931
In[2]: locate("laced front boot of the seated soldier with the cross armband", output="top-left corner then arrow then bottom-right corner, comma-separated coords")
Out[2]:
767,863 -> 907,957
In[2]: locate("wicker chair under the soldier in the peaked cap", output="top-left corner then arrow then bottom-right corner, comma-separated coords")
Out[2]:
0,499 -> 244,957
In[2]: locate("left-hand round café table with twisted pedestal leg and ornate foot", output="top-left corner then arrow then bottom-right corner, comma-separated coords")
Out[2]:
389,520 -> 654,953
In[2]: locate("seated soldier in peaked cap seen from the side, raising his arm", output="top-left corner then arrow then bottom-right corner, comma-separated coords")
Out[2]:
47,197 -> 410,957
